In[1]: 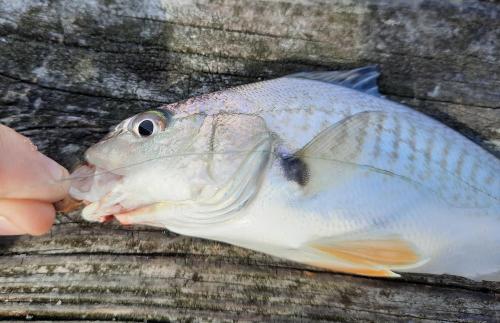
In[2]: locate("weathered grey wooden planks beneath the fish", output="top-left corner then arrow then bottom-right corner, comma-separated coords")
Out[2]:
0,0 -> 500,322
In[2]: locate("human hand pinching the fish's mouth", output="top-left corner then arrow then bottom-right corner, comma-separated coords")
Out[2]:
0,125 -> 69,235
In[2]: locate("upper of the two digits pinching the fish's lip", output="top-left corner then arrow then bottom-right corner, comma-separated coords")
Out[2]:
0,125 -> 69,202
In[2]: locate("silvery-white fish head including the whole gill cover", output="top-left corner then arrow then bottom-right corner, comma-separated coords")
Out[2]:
70,110 -> 272,233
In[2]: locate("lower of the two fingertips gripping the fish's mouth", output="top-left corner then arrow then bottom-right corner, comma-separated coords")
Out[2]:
0,199 -> 55,235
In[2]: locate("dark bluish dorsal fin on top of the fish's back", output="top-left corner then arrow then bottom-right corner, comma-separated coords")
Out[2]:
287,65 -> 382,97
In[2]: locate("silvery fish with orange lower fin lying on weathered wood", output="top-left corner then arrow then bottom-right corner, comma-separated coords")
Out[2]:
70,66 -> 500,280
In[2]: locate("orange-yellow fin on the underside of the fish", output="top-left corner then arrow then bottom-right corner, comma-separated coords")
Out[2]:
309,236 -> 425,277
